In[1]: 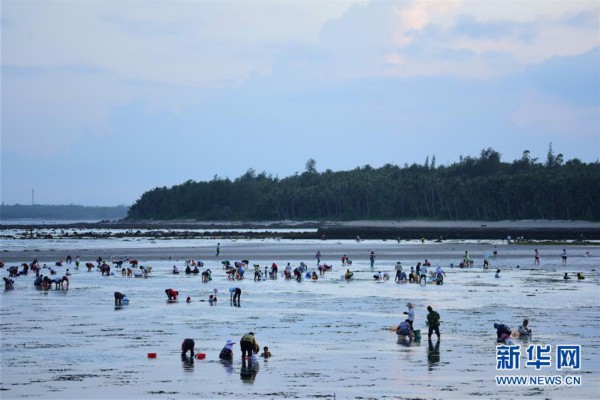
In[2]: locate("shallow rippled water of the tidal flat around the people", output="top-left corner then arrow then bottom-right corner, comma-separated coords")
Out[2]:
0,239 -> 600,399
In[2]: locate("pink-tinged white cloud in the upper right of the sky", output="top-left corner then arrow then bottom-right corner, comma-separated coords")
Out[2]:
381,1 -> 600,77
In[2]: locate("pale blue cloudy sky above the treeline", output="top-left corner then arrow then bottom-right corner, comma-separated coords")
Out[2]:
0,0 -> 600,206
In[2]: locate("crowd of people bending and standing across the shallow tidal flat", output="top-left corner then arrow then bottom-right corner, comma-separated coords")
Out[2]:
2,244 -> 585,364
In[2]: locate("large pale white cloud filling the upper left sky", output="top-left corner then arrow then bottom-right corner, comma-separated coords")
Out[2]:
2,1 -> 360,157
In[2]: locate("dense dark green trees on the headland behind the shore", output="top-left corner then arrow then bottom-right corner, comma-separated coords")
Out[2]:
128,146 -> 600,220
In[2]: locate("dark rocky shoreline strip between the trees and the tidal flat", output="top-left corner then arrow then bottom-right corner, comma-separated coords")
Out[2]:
0,220 -> 600,241
